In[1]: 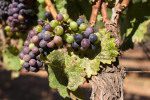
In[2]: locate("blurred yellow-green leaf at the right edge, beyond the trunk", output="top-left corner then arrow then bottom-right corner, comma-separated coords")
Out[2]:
132,20 -> 150,43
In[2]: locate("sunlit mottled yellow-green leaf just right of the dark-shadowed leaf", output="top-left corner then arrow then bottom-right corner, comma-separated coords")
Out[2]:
65,53 -> 86,91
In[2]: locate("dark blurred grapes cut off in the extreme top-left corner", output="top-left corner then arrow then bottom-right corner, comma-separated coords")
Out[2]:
0,0 -> 10,20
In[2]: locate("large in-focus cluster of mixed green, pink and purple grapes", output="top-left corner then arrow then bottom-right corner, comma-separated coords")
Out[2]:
19,14 -> 98,71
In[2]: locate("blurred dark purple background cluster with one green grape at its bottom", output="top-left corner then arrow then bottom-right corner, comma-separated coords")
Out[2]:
5,0 -> 35,32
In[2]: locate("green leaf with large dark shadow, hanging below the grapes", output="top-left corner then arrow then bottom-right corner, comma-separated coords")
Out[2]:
47,50 -> 69,98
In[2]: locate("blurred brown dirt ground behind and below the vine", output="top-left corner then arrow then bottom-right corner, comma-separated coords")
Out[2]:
0,43 -> 150,100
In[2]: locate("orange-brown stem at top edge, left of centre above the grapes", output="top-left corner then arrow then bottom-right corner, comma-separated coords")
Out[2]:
45,0 -> 57,19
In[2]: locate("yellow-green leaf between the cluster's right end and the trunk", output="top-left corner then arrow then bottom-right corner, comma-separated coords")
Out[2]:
96,29 -> 119,64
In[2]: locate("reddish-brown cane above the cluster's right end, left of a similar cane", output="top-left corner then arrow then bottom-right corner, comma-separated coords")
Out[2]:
89,0 -> 102,26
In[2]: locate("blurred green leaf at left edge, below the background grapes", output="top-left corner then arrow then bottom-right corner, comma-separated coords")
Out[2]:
3,47 -> 21,71
